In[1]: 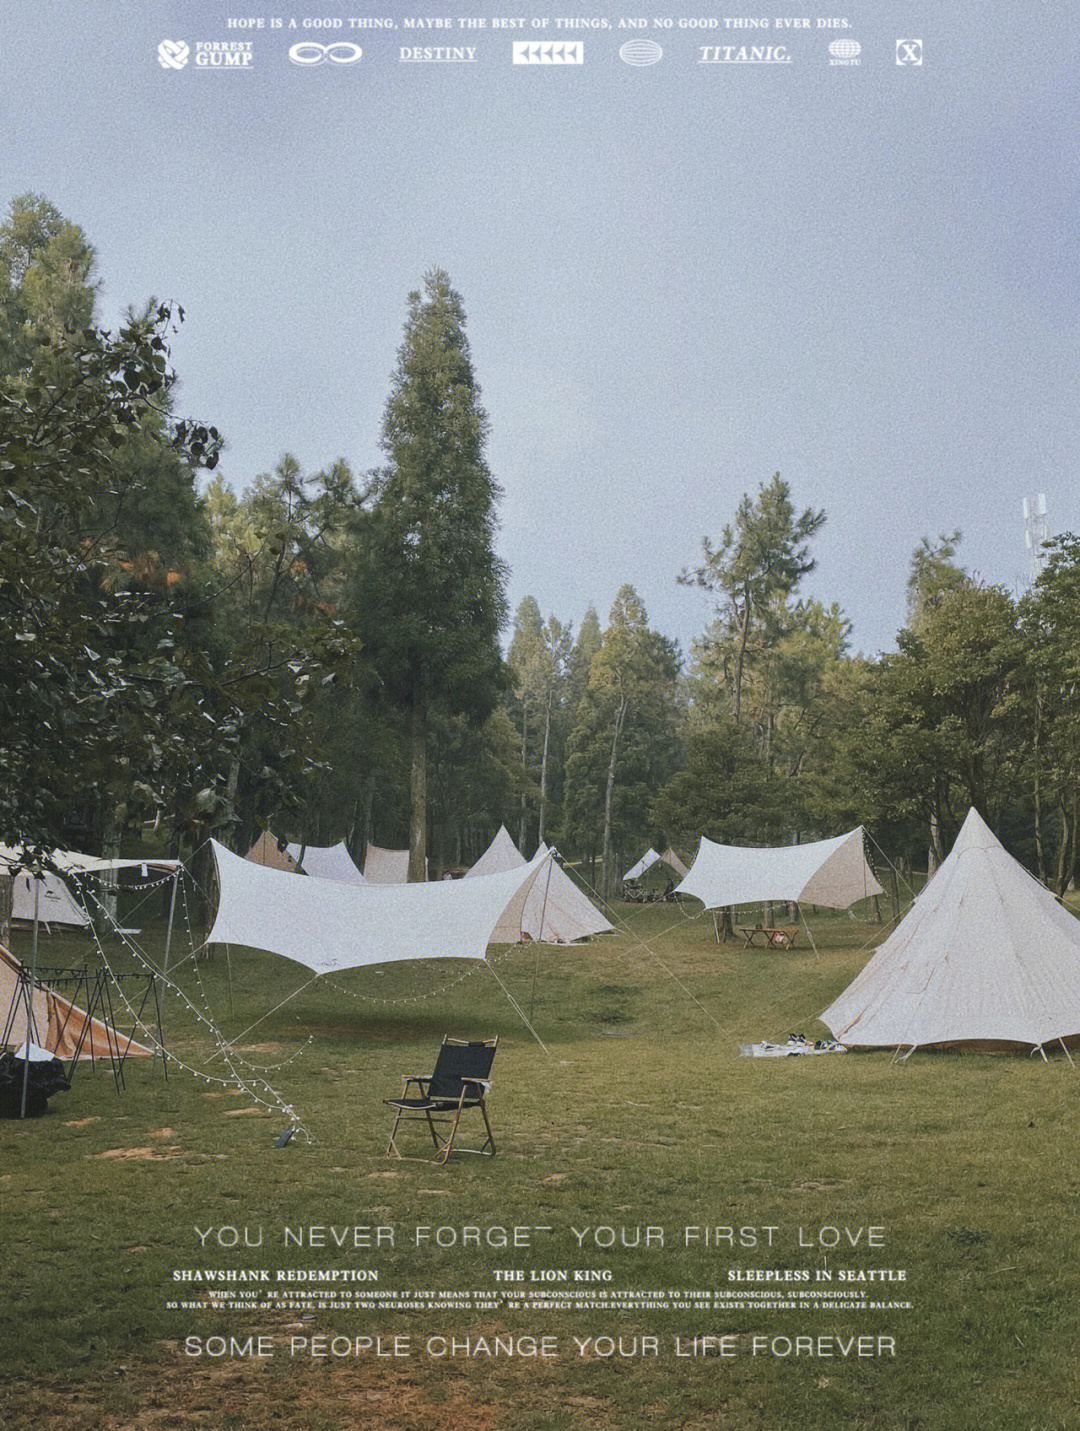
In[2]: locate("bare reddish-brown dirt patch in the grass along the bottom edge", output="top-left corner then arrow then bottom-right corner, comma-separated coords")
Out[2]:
0,1342 -> 506,1431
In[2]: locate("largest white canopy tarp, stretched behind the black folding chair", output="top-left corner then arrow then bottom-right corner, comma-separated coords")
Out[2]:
206,840 -> 549,975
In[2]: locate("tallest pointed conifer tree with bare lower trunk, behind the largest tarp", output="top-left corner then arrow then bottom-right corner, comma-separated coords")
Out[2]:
356,269 -> 506,880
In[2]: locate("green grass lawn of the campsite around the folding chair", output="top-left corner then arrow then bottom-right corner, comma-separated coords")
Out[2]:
0,906 -> 1080,1431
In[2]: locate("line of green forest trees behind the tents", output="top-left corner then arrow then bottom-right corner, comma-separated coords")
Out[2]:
0,195 -> 1080,896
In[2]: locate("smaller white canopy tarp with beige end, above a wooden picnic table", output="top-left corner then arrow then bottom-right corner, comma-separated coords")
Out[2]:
677,826 -> 883,909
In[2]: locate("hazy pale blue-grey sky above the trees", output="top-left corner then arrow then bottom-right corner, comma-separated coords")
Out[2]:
0,0 -> 1080,654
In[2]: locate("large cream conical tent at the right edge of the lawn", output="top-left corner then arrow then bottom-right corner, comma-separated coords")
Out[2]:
821,809 -> 1080,1047
